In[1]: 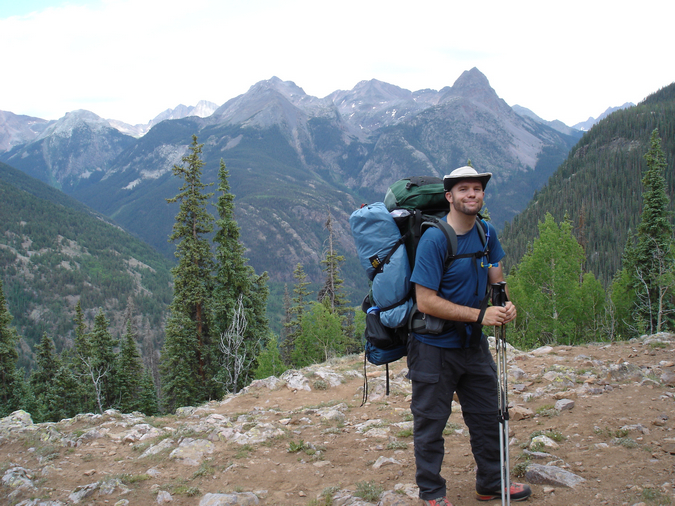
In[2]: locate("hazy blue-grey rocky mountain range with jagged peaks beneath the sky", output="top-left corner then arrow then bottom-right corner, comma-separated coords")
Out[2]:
0,68 -> 600,298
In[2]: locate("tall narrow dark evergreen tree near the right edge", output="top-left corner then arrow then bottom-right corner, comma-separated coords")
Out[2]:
624,129 -> 675,333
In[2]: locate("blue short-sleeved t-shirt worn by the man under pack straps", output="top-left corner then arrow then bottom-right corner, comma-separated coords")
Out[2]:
410,219 -> 504,348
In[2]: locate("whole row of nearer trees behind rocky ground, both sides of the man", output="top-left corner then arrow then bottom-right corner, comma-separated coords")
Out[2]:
0,129 -> 675,421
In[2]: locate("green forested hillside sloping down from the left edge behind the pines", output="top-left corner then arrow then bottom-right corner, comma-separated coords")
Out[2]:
0,163 -> 172,368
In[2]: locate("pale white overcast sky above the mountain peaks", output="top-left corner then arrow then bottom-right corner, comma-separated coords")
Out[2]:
0,0 -> 675,126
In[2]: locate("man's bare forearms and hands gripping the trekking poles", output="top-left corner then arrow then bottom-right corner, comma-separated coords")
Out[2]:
415,265 -> 516,325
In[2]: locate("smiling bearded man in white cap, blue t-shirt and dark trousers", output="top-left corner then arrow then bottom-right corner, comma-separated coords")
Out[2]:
408,167 -> 531,506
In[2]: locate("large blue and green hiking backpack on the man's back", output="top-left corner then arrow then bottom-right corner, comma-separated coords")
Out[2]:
349,177 -> 488,402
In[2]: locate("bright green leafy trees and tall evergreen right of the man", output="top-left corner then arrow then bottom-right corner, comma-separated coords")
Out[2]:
507,129 -> 675,349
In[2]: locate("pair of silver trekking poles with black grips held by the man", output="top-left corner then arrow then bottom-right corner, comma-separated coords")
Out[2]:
492,281 -> 511,506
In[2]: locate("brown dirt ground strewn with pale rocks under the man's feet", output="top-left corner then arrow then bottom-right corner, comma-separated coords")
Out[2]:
0,334 -> 675,506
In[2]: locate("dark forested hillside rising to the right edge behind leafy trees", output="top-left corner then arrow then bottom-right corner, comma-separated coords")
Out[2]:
502,83 -> 675,287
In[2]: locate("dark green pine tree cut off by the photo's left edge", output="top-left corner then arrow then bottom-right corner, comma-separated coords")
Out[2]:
0,280 -> 25,417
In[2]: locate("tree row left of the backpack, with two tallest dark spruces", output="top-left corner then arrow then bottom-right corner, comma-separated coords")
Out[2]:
0,136 -> 360,421
